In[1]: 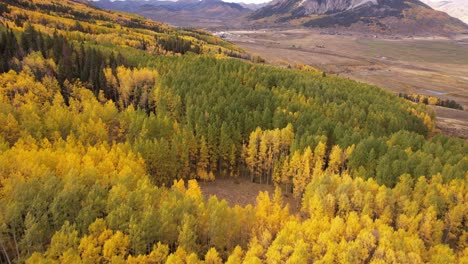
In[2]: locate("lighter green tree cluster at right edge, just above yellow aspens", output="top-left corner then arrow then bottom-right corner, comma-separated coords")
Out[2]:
349,131 -> 468,186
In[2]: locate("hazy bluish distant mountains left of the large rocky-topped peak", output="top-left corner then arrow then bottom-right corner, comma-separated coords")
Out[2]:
93,0 -> 252,28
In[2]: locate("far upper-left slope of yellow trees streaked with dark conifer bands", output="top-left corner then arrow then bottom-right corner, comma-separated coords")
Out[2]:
2,0 -> 242,55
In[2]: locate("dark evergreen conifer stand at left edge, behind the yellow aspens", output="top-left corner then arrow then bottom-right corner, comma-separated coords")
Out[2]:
0,24 -> 125,101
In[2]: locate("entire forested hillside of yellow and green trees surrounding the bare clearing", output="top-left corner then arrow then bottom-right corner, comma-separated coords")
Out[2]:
0,0 -> 468,263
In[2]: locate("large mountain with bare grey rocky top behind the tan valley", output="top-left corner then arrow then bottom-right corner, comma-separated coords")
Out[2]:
250,0 -> 468,35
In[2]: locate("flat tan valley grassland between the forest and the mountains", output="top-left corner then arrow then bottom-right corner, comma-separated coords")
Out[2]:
223,29 -> 468,138
